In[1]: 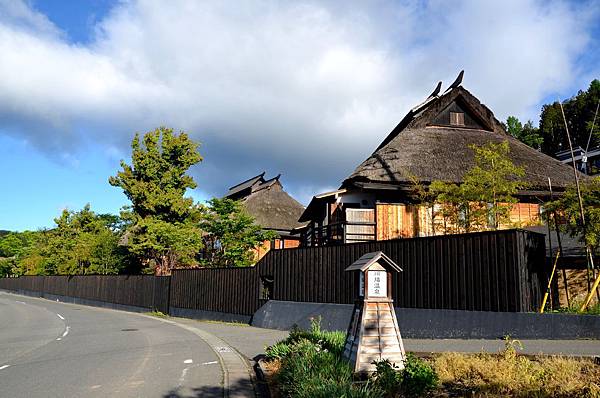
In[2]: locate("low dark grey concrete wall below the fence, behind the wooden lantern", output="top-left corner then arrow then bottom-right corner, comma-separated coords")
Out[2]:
252,301 -> 600,339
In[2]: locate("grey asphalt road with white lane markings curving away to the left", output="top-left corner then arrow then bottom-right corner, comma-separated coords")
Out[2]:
0,292 -> 223,398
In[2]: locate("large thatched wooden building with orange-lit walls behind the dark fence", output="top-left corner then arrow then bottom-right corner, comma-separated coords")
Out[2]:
297,82 -> 573,246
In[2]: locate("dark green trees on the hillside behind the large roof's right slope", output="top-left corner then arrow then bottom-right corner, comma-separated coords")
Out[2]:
539,79 -> 600,156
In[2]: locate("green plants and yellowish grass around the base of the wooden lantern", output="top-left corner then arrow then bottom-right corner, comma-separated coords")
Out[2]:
264,321 -> 600,398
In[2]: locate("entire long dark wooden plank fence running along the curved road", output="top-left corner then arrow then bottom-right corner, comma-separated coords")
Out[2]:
0,230 -> 547,316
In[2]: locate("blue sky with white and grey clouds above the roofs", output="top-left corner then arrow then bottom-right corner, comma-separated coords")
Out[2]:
0,0 -> 600,230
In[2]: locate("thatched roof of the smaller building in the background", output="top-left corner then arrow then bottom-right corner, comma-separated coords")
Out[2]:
225,173 -> 304,232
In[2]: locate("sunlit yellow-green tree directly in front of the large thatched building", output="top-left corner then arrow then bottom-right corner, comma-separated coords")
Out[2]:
430,141 -> 525,232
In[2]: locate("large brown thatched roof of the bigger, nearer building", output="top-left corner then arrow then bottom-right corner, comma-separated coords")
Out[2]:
342,87 -> 573,192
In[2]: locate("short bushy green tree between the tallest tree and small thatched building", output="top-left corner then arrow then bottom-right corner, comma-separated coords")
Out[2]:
200,198 -> 276,267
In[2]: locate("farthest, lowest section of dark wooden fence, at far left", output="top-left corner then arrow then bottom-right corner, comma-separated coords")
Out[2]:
0,275 -> 170,313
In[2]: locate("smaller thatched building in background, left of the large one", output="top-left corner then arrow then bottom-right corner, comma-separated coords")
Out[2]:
225,172 -> 304,260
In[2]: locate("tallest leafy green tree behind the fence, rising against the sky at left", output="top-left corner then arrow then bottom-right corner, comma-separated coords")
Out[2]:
109,127 -> 202,274
